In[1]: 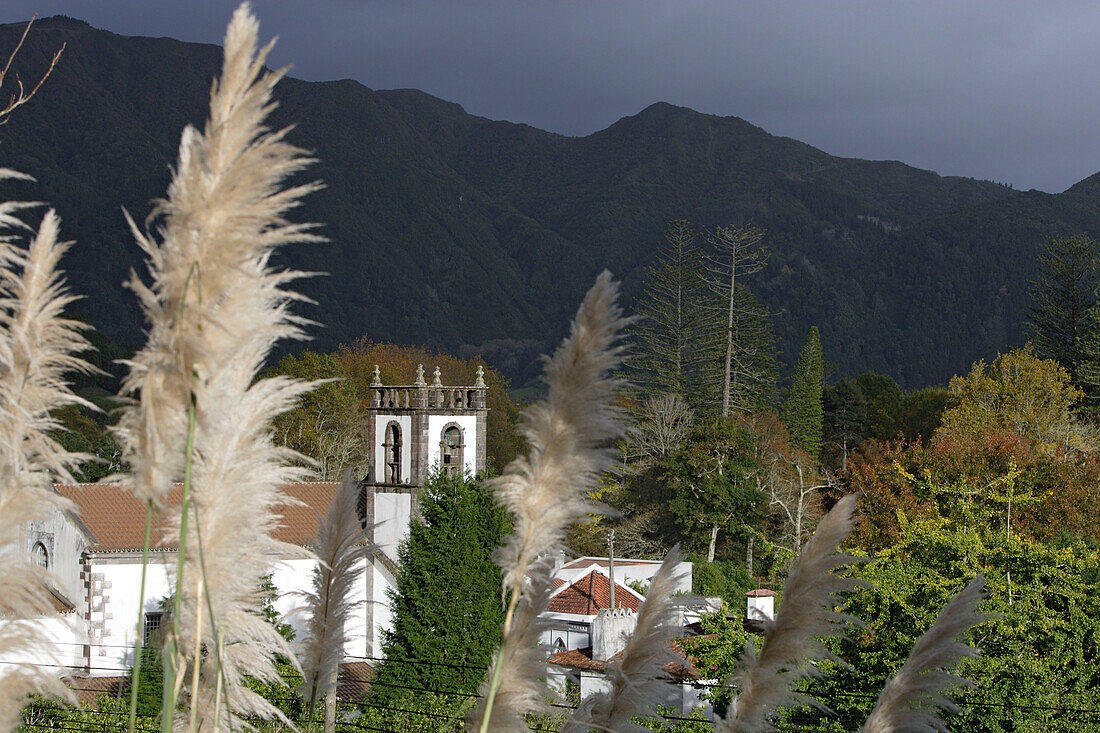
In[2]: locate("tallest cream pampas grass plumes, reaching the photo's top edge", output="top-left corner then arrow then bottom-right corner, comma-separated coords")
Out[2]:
117,6 -> 318,731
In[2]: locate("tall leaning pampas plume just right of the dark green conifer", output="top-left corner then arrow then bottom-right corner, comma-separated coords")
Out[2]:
468,272 -> 628,732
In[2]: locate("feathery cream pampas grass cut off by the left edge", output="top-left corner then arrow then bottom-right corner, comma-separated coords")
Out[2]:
0,188 -> 95,731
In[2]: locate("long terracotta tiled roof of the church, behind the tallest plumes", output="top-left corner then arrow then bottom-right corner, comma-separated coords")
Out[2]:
55,481 -> 339,553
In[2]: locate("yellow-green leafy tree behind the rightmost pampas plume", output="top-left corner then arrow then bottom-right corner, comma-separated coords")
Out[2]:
805,517 -> 1100,733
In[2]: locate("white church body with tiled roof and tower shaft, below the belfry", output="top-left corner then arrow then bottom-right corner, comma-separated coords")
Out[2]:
0,482 -> 416,677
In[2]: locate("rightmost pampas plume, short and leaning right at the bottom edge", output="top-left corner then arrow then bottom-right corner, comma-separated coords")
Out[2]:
861,576 -> 987,733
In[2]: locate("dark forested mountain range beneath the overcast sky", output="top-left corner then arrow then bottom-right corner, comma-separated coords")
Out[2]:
0,18 -> 1100,386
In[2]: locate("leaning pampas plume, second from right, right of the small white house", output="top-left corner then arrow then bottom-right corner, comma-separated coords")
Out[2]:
715,494 -> 858,733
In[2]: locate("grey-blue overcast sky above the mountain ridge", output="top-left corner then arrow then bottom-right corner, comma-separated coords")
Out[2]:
0,0 -> 1100,192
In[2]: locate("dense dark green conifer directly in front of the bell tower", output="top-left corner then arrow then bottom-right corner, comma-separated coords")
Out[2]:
371,473 -> 508,704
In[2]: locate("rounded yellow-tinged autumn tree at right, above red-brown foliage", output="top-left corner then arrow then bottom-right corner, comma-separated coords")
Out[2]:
935,347 -> 1092,455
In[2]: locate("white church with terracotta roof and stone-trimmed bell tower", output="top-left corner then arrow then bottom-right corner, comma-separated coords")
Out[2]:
0,365 -> 488,677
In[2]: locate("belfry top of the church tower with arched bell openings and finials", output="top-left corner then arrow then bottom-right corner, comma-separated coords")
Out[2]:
364,364 -> 488,488
